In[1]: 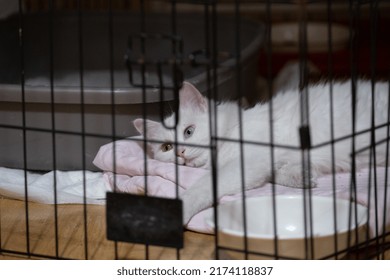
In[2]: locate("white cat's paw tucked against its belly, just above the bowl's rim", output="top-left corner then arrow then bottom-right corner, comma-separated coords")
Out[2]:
274,164 -> 317,188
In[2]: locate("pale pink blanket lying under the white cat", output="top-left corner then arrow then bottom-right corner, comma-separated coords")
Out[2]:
93,138 -> 390,236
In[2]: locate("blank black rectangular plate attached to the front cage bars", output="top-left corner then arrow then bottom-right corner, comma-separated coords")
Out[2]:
107,192 -> 183,248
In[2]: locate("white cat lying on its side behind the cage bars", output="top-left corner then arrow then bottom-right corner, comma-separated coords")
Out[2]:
134,81 -> 389,224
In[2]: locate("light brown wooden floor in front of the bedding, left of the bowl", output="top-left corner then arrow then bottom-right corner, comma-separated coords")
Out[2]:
0,198 -> 214,260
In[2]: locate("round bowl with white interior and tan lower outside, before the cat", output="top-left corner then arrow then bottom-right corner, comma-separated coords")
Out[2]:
206,195 -> 367,259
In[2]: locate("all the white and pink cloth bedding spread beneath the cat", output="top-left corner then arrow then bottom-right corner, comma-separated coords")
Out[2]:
0,139 -> 390,236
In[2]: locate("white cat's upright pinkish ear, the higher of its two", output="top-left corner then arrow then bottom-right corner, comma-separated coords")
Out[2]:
179,82 -> 208,112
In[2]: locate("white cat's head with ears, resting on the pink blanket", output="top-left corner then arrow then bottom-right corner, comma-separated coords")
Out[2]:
134,82 -> 210,168
